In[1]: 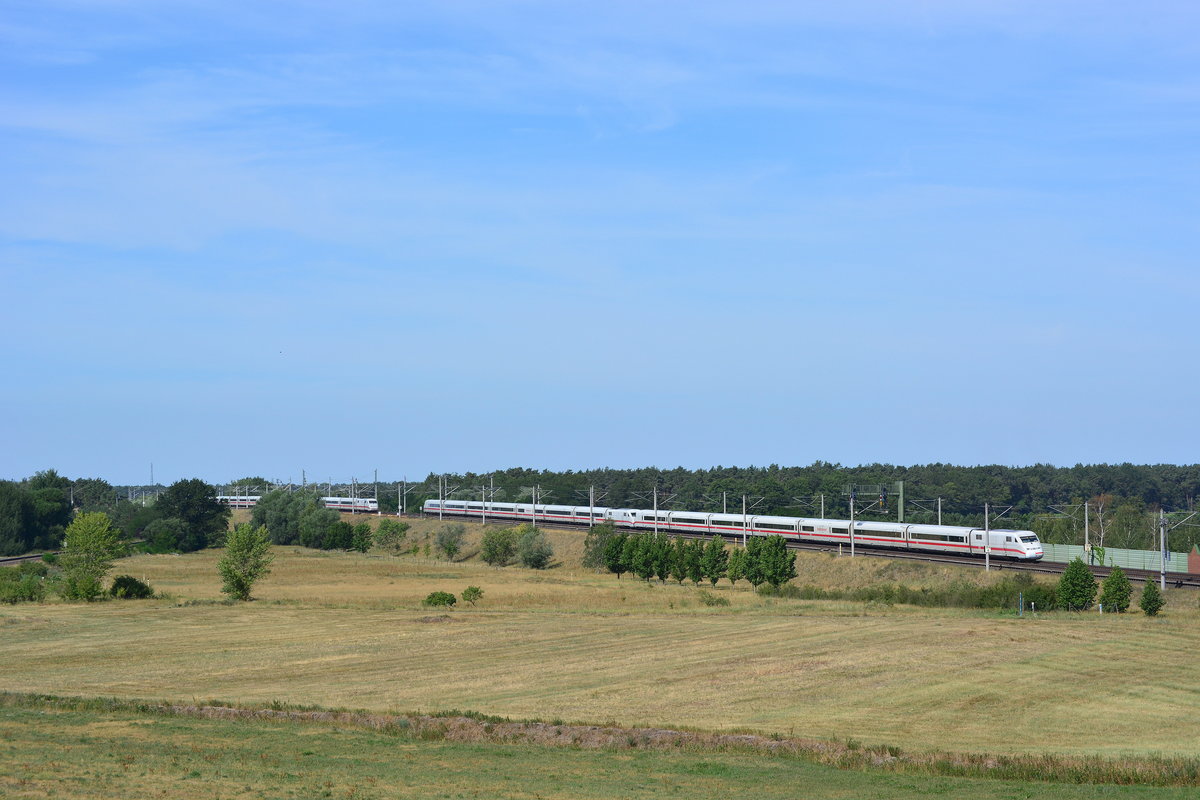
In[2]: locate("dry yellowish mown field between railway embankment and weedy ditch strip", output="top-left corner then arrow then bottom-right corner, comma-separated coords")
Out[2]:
0,522 -> 1200,757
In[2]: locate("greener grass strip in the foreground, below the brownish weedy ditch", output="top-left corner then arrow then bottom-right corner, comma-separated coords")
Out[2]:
0,703 -> 1195,800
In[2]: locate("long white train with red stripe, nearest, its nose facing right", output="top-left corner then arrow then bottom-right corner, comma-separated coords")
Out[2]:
425,500 -> 1043,561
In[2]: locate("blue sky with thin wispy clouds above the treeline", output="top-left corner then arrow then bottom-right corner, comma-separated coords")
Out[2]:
0,0 -> 1200,483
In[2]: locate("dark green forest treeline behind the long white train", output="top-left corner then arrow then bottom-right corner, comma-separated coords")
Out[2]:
410,462 -> 1200,551
